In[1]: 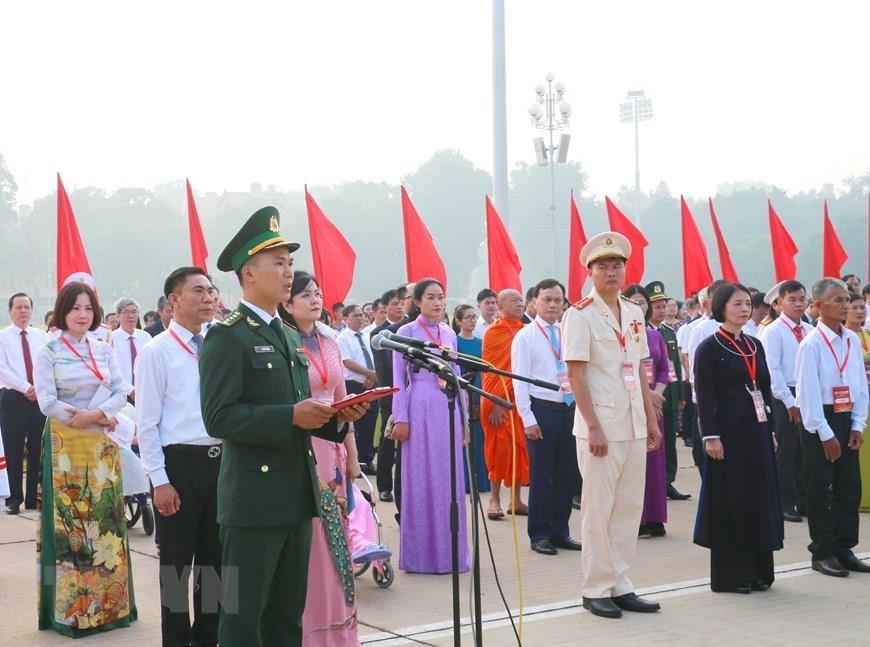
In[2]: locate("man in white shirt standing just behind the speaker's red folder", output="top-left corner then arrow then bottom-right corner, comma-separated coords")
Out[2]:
337,304 -> 378,476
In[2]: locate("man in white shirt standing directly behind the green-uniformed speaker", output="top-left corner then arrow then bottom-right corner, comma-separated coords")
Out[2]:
135,267 -> 222,647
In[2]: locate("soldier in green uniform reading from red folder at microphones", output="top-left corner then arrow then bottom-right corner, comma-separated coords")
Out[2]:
200,207 -> 368,647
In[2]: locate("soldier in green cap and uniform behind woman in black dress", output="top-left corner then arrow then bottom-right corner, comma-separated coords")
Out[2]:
644,281 -> 692,501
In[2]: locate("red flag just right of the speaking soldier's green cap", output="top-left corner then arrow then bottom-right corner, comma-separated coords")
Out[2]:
305,186 -> 356,310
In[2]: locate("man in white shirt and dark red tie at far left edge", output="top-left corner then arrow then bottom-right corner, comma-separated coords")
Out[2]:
0,292 -> 48,514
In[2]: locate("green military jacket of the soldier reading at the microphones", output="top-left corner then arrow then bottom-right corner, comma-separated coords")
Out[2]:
199,304 -> 344,527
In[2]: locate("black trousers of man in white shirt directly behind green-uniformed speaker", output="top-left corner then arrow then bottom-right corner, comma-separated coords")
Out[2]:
157,445 -> 221,647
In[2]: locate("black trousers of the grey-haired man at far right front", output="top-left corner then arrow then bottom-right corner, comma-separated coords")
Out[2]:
801,405 -> 861,559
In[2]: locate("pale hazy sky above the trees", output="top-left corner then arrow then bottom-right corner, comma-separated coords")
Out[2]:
0,0 -> 870,202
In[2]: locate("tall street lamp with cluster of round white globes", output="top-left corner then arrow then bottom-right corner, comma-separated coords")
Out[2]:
529,73 -> 571,276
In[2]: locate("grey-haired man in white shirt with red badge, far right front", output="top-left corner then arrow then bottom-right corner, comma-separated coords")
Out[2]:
796,279 -> 870,577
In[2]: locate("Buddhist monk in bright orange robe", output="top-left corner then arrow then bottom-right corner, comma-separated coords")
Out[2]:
480,290 -> 529,519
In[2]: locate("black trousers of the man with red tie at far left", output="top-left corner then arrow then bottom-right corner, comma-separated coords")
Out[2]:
0,389 -> 45,509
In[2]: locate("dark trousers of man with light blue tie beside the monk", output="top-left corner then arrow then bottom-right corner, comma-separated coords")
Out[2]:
526,398 -> 579,541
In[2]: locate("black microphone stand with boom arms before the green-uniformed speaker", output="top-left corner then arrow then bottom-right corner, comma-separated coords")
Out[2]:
402,348 -> 560,647
